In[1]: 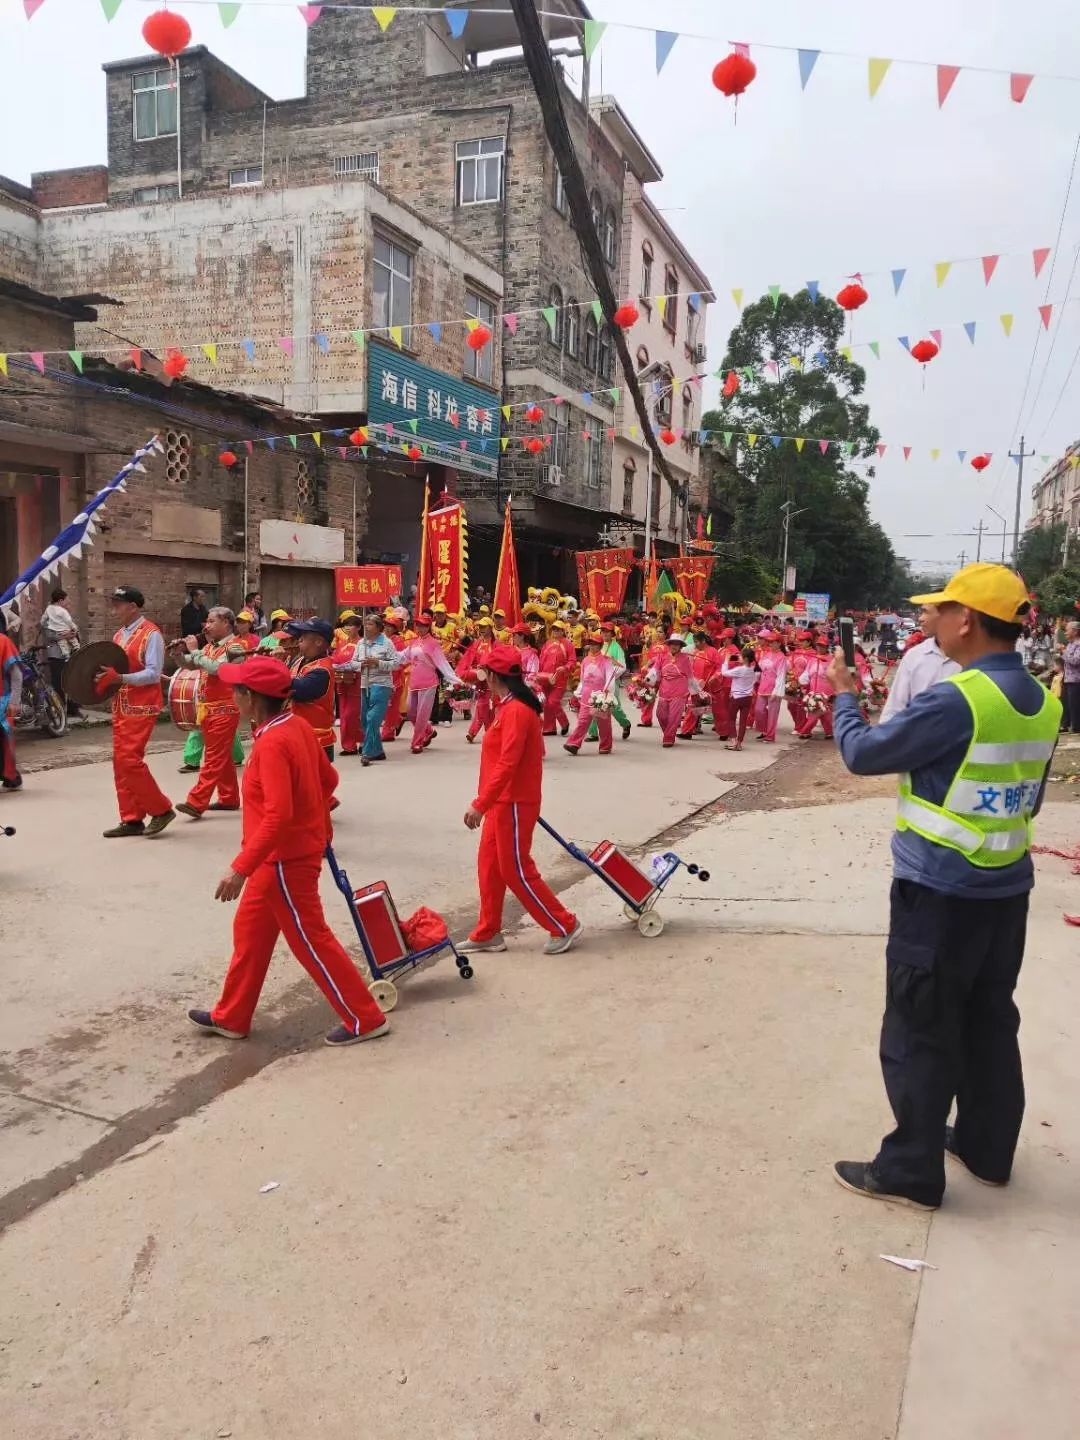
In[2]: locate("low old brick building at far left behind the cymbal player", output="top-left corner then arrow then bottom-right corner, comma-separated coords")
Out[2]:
0,282 -> 380,638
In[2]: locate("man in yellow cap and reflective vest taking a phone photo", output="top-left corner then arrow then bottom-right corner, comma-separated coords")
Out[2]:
829,564 -> 1061,1210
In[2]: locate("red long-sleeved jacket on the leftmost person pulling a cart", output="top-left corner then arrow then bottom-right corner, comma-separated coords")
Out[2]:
232,710 -> 337,876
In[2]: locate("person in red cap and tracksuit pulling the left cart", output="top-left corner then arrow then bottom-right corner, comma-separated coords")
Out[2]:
187,657 -> 390,1045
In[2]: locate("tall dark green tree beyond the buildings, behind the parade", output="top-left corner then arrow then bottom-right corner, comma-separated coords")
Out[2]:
701,291 -> 897,608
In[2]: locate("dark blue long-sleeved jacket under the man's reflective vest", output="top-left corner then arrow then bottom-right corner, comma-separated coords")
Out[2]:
835,652 -> 1050,900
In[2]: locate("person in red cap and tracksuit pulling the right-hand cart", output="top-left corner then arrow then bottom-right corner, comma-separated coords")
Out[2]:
458,645 -> 582,955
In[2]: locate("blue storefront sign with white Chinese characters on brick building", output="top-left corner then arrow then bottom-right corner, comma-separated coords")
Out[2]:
367,341 -> 500,480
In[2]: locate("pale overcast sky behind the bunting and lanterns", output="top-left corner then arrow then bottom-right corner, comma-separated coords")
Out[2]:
0,0 -> 1080,564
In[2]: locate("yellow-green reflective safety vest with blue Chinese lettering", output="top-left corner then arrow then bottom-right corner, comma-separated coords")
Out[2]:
896,670 -> 1061,870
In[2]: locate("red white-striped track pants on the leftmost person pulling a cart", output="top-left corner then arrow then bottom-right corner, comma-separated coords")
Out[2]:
212,855 -> 383,1035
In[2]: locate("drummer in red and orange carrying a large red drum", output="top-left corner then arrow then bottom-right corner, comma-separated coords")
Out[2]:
168,605 -> 240,819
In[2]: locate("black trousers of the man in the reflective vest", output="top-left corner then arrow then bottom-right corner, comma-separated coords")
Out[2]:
874,880 -> 1028,1205
